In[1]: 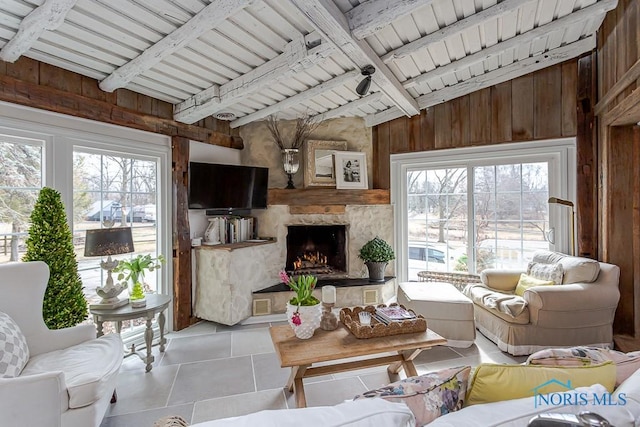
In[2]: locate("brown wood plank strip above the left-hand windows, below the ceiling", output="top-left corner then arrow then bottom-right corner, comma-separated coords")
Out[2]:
0,57 -> 243,148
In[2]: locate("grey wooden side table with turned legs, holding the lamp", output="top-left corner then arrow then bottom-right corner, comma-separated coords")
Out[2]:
89,294 -> 171,372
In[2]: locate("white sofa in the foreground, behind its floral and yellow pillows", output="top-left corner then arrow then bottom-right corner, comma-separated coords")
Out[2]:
171,370 -> 640,427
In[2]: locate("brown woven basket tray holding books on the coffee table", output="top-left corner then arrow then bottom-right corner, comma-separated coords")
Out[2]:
340,304 -> 427,338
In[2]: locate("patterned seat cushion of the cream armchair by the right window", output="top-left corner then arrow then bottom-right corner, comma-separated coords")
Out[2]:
464,285 -> 529,325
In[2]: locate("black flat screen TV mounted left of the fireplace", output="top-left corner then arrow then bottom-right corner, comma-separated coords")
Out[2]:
188,162 -> 269,210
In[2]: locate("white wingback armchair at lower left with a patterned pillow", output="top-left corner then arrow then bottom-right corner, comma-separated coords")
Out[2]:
0,261 -> 123,427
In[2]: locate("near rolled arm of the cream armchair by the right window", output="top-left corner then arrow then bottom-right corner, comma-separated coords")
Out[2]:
524,283 -> 620,328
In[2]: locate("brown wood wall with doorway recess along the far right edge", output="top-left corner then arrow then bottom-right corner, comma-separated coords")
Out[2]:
596,0 -> 640,351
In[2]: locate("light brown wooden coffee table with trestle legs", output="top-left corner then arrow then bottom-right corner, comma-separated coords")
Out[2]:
269,324 -> 447,408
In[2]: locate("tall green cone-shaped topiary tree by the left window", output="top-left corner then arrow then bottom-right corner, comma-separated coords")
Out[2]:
22,187 -> 87,329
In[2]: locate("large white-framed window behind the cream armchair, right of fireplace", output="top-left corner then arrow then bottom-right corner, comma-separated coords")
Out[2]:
392,140 -> 575,280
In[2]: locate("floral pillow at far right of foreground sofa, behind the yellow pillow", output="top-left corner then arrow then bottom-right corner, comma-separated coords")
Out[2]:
525,347 -> 640,387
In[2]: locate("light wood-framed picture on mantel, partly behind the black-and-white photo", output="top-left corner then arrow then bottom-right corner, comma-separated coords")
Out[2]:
304,140 -> 347,187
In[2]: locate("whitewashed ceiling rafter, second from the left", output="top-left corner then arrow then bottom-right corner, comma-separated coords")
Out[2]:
100,0 -> 257,92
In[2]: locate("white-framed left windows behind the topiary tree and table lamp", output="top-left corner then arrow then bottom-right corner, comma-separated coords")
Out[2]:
0,103 -> 172,344
